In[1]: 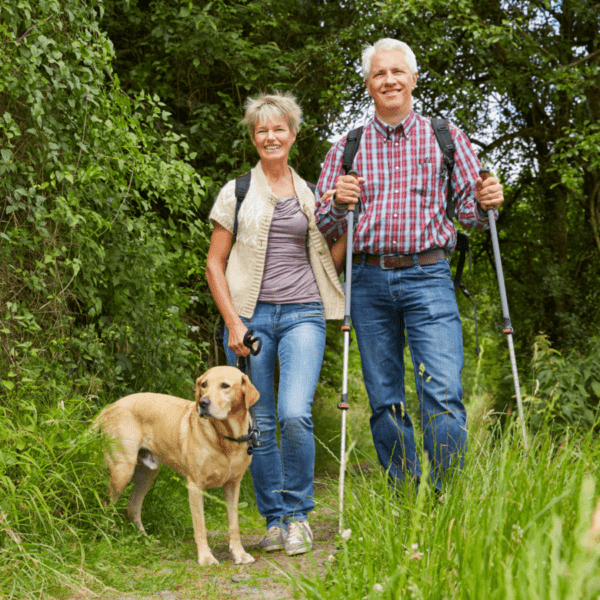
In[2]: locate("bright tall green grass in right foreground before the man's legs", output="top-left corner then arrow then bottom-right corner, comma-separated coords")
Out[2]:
294,414 -> 600,600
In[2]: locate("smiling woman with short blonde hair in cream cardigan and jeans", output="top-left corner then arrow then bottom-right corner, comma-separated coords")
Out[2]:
206,93 -> 344,556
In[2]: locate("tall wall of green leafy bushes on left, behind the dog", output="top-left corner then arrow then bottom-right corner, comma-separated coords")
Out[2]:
0,0 -> 208,394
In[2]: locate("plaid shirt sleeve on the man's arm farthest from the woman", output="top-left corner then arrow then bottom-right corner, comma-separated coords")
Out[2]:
452,128 -> 498,229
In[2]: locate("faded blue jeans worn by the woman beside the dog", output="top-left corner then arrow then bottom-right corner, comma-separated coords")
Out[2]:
224,302 -> 325,529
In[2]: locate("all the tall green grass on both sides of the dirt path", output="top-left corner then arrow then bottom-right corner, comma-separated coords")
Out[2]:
0,330 -> 600,600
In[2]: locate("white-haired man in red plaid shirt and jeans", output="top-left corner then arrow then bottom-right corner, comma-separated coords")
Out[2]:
315,38 -> 504,489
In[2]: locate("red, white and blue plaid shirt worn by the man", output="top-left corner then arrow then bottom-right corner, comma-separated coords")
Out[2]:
315,111 -> 489,254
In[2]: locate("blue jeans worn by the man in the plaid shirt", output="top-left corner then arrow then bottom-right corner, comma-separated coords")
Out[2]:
351,255 -> 467,489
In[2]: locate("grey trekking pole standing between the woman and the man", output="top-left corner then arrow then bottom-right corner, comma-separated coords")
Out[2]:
338,170 -> 358,535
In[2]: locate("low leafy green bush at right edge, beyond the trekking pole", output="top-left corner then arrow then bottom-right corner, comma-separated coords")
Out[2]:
525,335 -> 600,436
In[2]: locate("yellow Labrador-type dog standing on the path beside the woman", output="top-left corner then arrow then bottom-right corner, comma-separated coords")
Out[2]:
96,367 -> 259,566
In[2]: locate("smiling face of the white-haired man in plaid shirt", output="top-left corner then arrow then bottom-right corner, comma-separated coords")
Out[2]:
365,50 -> 417,120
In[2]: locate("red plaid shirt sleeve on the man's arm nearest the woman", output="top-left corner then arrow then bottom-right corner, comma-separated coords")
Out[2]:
315,136 -> 348,238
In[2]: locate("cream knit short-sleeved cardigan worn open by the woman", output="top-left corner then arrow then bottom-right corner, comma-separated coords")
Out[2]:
209,161 -> 344,319
